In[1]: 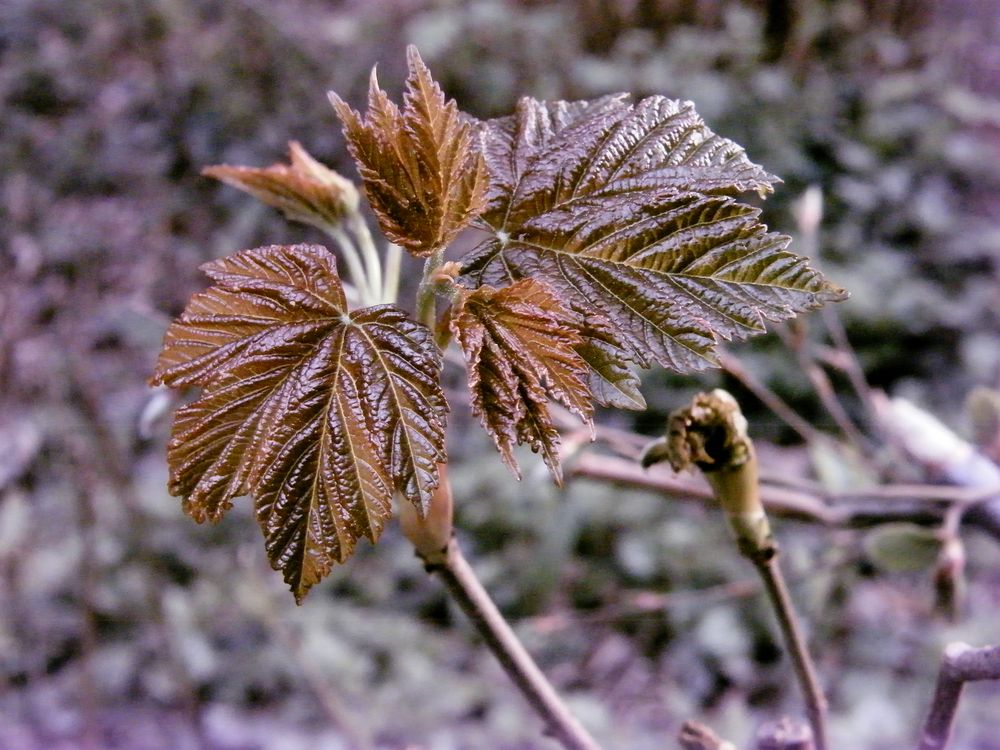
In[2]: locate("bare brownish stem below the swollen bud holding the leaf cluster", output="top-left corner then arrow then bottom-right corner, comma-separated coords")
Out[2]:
428,539 -> 600,750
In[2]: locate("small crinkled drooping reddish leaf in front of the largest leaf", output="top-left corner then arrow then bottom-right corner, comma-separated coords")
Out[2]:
451,279 -> 592,481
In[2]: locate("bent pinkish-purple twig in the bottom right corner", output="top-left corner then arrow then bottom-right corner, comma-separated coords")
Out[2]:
918,643 -> 1000,750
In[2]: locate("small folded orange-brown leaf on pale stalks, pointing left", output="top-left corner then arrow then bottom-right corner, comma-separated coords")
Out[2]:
201,141 -> 358,229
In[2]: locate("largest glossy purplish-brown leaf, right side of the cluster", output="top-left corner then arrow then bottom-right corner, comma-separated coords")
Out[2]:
462,95 -> 846,394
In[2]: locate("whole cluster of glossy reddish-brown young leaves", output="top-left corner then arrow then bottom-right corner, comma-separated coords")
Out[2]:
154,47 -> 844,598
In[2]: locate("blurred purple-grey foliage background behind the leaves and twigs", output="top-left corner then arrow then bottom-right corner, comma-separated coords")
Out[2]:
0,0 -> 1000,750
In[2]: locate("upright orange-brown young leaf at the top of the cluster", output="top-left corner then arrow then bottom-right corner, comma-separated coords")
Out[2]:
330,46 -> 487,256
